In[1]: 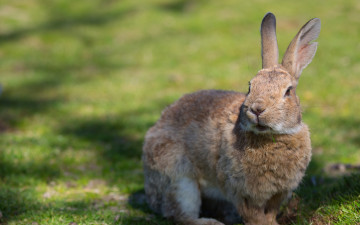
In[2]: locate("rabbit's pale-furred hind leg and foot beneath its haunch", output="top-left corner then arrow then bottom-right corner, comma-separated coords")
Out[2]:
162,177 -> 223,225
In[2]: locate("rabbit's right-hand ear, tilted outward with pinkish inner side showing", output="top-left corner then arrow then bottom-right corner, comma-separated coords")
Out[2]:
282,18 -> 321,79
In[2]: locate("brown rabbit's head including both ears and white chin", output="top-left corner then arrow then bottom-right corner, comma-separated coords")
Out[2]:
239,13 -> 320,134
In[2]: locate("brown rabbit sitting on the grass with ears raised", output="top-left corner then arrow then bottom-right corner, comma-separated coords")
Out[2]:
142,13 -> 320,225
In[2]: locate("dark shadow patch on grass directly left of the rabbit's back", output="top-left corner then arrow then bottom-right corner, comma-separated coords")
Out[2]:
59,97 -> 170,163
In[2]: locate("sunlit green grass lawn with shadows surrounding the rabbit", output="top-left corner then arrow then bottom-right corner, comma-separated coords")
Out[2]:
0,0 -> 360,224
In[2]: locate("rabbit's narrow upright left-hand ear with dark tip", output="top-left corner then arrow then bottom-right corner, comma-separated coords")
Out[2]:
260,12 -> 279,69
